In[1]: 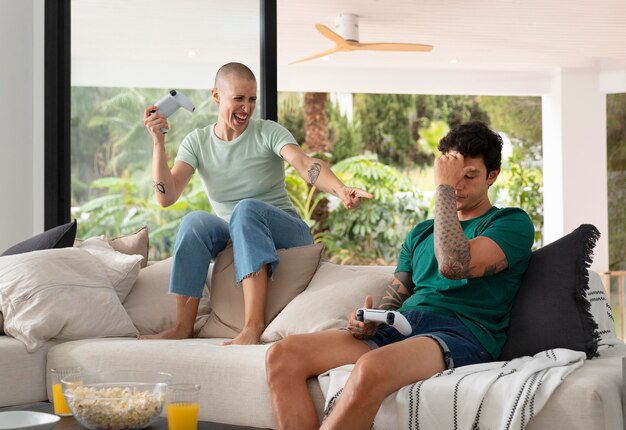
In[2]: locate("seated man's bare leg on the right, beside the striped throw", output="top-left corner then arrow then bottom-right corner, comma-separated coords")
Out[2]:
320,336 -> 446,430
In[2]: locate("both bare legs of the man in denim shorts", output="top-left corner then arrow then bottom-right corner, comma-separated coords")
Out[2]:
266,330 -> 446,430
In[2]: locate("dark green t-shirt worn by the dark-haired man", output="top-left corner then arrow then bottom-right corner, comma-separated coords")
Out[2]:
396,206 -> 534,360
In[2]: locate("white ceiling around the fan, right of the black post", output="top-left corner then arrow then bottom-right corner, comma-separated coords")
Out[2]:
278,0 -> 626,71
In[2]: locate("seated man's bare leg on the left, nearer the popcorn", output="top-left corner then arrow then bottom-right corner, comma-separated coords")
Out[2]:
265,330 -> 370,430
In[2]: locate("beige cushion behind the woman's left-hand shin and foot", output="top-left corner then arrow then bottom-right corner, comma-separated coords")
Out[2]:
124,257 -> 211,335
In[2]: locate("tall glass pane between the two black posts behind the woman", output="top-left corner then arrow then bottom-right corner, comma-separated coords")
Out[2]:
71,0 -> 263,260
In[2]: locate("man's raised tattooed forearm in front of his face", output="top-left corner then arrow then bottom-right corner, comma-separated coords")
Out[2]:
435,185 -> 471,279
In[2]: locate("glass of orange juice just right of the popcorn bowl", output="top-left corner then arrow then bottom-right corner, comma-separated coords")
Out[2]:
165,384 -> 200,430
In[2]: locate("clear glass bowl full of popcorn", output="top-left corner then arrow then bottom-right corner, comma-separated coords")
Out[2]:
61,370 -> 172,430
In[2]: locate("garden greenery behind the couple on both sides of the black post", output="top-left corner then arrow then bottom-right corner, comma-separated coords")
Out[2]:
72,92 -> 543,264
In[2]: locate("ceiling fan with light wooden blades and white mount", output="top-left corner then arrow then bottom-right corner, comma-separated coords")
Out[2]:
289,13 -> 433,64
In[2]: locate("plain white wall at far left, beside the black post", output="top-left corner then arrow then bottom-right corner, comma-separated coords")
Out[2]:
0,0 -> 43,252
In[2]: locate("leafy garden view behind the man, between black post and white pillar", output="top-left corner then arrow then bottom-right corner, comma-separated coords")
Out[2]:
278,91 -> 543,265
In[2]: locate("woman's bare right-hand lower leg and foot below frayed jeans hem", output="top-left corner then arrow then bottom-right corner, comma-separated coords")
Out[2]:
222,265 -> 268,345
